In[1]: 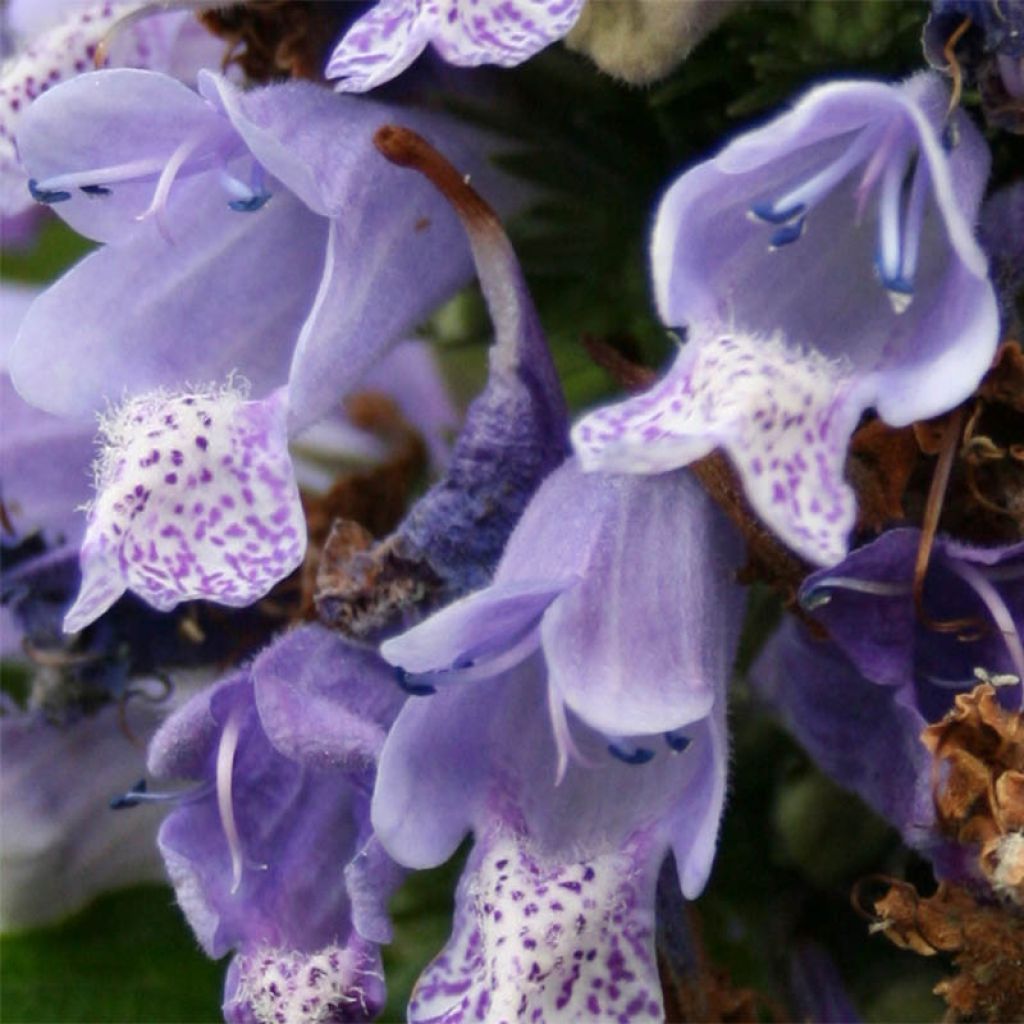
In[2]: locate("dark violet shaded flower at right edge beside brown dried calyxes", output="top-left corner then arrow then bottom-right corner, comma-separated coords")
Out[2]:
753,529 -> 1024,856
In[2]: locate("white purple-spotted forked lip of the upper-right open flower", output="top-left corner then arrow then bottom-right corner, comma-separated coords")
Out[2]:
572,331 -> 862,565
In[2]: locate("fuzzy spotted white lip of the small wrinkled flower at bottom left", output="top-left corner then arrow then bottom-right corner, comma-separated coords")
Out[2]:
224,946 -> 382,1024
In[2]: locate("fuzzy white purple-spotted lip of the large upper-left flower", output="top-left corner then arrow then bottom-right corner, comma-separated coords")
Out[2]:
65,388 -> 306,633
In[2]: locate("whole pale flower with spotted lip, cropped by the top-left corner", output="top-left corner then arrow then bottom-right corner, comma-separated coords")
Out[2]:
0,0 -> 223,219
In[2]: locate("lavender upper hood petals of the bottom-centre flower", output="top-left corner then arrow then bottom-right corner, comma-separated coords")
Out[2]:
381,460 -> 742,768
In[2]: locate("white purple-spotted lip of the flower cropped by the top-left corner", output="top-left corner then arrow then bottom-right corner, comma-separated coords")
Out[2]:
0,0 -> 144,214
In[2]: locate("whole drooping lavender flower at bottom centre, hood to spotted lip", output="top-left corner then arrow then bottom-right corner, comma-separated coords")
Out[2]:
372,463 -> 740,1021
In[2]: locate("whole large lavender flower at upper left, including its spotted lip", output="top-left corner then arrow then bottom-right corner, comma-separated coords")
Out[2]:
10,71 -> 512,630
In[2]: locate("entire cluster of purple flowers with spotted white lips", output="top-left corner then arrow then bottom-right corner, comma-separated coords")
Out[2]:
0,0 -> 1024,1024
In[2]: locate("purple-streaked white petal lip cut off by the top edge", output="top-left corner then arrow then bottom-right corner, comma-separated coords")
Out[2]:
327,0 -> 585,92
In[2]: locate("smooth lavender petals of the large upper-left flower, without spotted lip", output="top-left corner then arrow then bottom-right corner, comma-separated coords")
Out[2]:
10,70 -> 509,429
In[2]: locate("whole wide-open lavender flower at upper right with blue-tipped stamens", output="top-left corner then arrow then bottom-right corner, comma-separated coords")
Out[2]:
573,75 -> 998,565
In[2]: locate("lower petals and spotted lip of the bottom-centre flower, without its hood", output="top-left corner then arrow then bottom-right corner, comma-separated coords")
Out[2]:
372,655 -> 726,1022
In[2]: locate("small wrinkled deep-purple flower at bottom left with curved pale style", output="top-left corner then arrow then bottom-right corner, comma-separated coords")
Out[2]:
148,627 -> 401,1024
